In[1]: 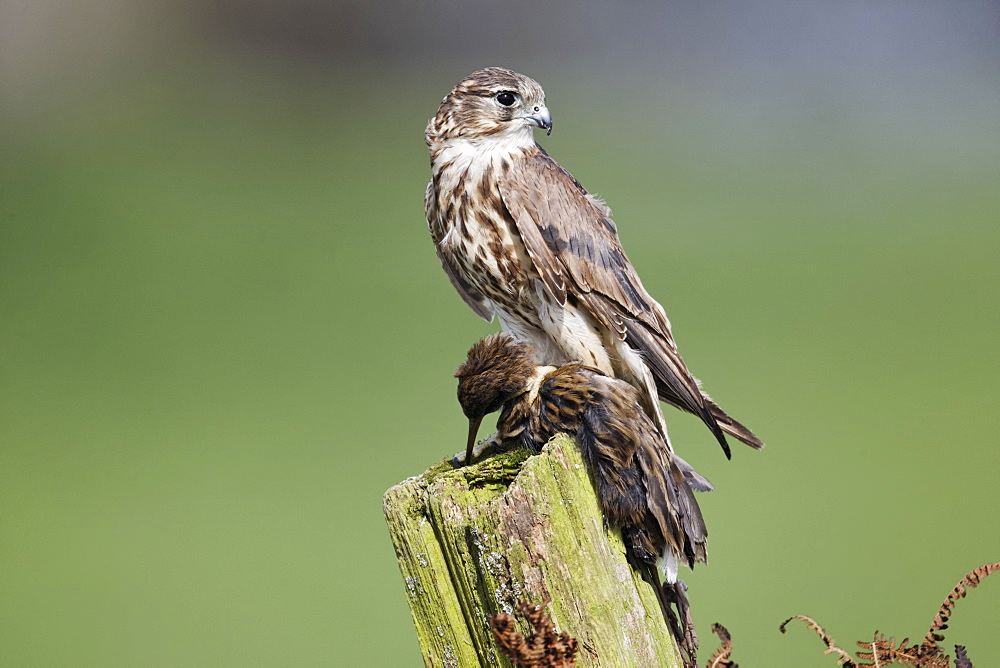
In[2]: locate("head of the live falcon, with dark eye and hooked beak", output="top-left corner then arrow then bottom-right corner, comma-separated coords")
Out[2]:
427,67 -> 552,140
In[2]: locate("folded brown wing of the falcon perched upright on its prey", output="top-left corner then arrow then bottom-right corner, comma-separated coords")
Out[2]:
500,148 -> 759,453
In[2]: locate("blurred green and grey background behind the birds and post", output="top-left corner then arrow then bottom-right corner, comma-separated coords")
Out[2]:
0,0 -> 1000,666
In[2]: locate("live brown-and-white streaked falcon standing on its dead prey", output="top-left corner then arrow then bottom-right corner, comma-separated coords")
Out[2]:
424,67 -> 763,457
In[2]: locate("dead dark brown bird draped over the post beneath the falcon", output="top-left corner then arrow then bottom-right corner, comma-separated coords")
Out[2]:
455,332 -> 712,655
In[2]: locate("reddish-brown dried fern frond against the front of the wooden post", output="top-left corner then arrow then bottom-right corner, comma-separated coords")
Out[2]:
490,599 -> 579,668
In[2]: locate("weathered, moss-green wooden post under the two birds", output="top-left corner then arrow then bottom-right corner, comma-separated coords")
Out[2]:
383,435 -> 682,667
